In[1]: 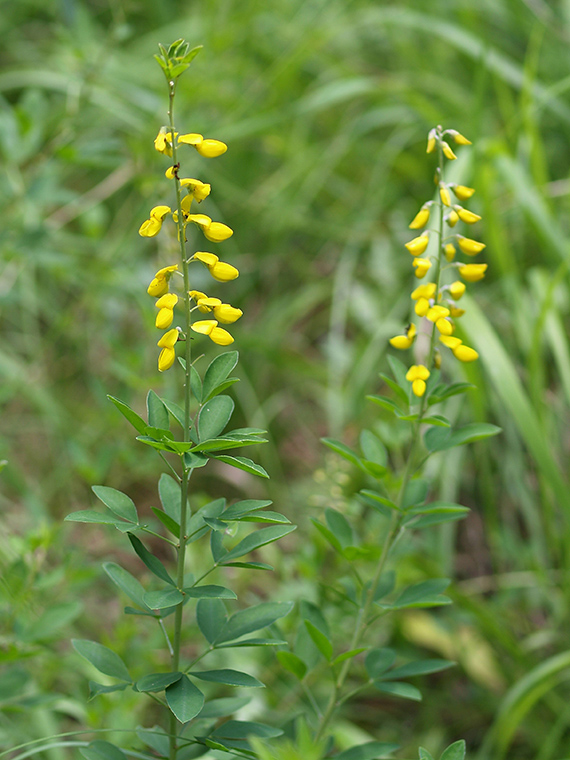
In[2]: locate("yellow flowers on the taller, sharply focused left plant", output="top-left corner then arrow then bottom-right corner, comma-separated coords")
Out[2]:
139,127 -> 243,372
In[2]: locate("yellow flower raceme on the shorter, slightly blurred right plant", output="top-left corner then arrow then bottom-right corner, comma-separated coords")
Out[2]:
390,126 -> 487,397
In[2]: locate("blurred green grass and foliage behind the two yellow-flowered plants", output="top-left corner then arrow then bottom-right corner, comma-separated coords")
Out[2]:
0,0 -> 570,760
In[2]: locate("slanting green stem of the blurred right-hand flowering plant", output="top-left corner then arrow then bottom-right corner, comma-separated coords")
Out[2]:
315,128 -> 444,741
